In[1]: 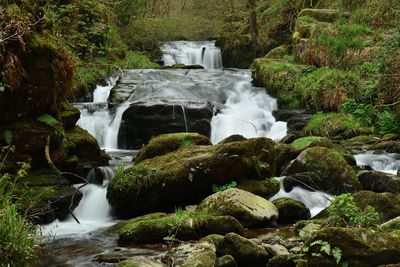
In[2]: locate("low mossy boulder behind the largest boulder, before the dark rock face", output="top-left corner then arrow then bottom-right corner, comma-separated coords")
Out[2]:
135,133 -> 212,163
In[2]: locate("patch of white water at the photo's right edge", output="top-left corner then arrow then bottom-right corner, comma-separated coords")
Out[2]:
354,151 -> 400,174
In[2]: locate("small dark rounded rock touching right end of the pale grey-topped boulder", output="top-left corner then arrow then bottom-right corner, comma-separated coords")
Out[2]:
272,197 -> 311,225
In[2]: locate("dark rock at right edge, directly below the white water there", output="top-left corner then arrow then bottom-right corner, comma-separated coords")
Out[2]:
357,171 -> 400,194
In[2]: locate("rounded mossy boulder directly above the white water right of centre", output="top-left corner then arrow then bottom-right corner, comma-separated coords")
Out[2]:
285,147 -> 361,194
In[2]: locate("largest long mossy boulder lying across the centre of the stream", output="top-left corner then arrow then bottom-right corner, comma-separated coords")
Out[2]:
107,138 -> 276,216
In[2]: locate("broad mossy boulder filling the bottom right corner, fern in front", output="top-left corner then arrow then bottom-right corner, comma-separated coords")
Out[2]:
297,227 -> 400,266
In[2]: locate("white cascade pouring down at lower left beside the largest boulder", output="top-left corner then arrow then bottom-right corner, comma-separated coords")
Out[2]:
42,167 -> 117,239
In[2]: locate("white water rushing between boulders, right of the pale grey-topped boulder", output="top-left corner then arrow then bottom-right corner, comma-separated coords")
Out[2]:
269,177 -> 333,217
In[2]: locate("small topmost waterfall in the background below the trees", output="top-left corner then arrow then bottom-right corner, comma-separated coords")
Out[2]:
161,41 -> 222,69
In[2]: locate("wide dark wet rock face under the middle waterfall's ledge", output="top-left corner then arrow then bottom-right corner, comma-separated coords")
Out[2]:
118,99 -> 213,149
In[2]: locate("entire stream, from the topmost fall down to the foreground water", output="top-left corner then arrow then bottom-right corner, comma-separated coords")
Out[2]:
41,41 -> 400,266
